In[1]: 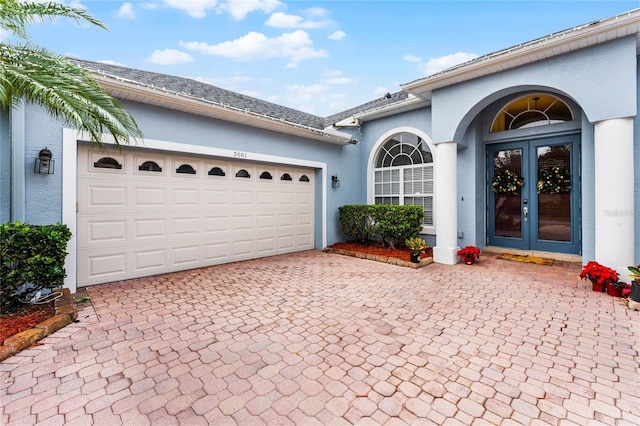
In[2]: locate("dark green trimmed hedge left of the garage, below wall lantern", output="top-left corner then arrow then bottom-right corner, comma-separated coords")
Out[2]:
0,222 -> 71,310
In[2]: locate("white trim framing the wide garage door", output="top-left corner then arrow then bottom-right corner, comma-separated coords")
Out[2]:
62,129 -> 327,293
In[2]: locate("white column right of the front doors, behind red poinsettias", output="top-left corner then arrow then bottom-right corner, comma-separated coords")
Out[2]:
587,118 -> 635,272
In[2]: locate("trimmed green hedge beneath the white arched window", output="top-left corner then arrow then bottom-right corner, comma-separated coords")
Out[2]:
338,204 -> 424,248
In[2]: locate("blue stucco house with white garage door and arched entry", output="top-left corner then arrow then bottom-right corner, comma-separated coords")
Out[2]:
0,9 -> 640,290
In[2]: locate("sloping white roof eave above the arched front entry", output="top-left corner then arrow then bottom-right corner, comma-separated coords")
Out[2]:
400,9 -> 640,100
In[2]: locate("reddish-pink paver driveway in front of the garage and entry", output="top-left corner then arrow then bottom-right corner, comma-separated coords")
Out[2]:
0,251 -> 640,426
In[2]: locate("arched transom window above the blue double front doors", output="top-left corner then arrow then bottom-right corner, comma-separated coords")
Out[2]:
491,93 -> 573,133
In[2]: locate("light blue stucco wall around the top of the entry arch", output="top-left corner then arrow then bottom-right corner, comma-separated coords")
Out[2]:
432,36 -> 637,143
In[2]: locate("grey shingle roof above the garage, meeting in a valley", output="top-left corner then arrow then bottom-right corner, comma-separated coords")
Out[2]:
69,58 -> 407,130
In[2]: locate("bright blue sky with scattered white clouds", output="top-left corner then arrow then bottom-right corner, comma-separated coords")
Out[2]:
17,0 -> 640,116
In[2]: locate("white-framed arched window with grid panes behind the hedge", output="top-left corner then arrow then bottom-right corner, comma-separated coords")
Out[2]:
373,133 -> 433,226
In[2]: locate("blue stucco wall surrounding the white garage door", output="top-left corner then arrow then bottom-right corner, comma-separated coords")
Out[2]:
16,101 -> 363,248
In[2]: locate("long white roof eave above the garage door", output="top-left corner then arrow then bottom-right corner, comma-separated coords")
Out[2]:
92,72 -> 356,145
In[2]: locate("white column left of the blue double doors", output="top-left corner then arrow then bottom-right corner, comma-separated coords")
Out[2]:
433,142 -> 459,265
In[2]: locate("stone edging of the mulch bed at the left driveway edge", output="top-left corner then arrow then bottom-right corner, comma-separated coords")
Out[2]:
0,288 -> 78,361
